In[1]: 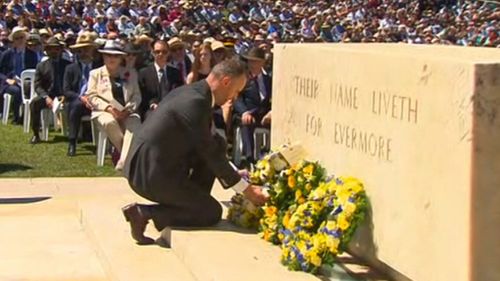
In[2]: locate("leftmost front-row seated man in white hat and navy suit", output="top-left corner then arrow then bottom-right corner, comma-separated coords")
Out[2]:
0,26 -> 38,124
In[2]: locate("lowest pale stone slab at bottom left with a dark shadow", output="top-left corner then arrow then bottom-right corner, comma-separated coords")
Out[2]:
0,196 -> 108,281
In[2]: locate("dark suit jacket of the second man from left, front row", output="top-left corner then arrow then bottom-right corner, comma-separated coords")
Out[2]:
35,58 -> 70,98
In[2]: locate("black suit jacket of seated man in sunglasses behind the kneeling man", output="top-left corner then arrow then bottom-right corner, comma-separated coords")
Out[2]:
139,64 -> 184,113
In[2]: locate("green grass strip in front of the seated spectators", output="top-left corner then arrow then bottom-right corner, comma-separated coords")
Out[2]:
0,123 -> 120,177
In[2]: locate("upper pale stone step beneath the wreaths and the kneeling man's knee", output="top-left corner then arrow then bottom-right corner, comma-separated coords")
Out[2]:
162,184 -> 386,281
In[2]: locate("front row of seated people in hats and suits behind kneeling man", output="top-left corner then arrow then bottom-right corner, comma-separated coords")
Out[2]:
0,31 -> 271,169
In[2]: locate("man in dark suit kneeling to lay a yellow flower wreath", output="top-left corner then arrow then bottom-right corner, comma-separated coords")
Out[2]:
123,59 -> 267,244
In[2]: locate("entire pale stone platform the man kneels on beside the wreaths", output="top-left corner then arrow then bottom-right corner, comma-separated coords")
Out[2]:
0,178 -> 385,281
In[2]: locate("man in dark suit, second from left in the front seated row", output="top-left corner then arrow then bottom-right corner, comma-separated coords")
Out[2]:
30,37 -> 70,144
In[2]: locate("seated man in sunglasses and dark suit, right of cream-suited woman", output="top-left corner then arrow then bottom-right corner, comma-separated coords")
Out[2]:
139,40 -> 184,120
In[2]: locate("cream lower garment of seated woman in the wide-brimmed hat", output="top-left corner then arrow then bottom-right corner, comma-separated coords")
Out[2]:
97,112 -> 141,161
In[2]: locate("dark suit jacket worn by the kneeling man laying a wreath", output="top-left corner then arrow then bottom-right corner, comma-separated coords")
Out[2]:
124,80 -> 241,191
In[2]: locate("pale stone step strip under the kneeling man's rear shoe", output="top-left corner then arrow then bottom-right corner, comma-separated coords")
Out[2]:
79,196 -> 195,281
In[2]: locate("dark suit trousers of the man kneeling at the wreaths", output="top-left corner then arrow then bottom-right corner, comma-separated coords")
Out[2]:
132,153 -> 222,231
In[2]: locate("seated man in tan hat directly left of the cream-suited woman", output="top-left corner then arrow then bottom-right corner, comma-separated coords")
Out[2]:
63,32 -> 99,156
